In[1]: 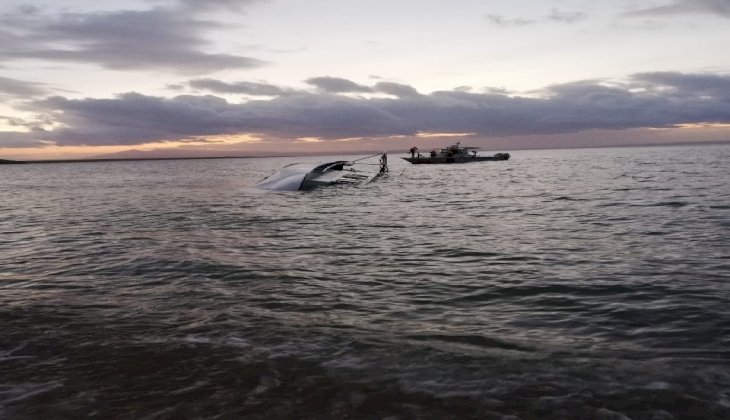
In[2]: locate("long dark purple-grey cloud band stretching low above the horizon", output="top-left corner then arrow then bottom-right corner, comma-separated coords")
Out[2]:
2,72 -> 730,149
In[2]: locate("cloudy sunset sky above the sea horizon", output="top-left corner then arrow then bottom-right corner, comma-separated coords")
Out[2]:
0,0 -> 730,159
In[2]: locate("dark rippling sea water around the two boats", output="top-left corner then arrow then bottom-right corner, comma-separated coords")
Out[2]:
0,146 -> 730,420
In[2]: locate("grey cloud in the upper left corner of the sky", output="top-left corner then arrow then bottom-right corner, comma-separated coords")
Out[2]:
0,8 -> 264,74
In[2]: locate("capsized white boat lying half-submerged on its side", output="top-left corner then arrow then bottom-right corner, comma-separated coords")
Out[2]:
256,153 -> 388,191
